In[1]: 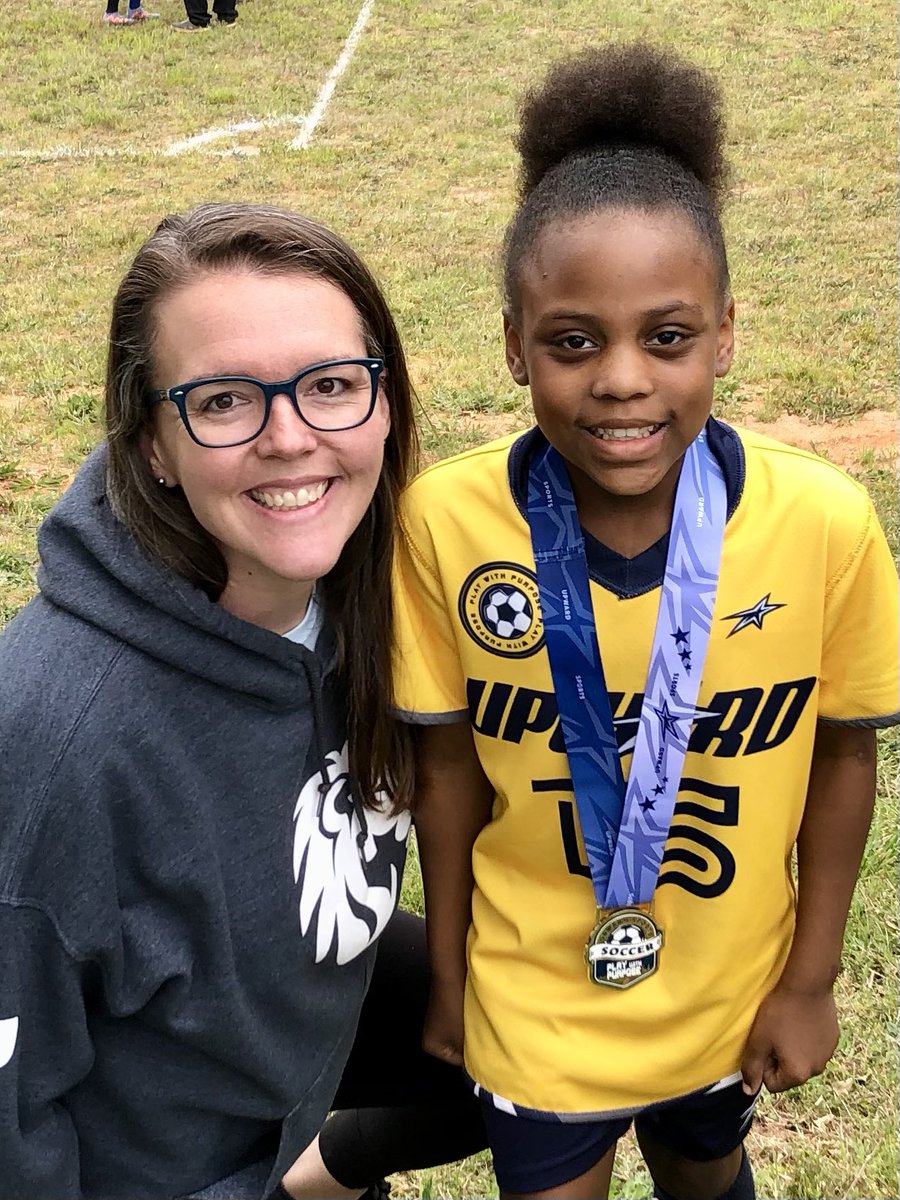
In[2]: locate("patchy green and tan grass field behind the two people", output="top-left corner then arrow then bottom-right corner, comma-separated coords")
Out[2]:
0,0 -> 898,1200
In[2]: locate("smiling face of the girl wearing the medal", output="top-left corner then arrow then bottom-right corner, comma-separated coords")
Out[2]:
504,210 -> 734,530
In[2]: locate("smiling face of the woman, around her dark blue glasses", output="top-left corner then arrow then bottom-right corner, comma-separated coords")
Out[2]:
145,269 -> 390,632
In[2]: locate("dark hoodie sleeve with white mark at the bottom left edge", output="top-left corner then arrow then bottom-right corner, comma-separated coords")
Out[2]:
0,902 -> 92,1200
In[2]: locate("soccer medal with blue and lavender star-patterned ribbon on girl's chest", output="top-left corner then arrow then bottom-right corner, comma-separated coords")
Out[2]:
528,431 -> 727,988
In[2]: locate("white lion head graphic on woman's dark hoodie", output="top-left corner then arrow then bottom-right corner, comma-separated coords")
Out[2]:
294,743 -> 410,966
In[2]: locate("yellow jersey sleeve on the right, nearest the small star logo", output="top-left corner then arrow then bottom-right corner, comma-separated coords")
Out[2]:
818,493 -> 900,727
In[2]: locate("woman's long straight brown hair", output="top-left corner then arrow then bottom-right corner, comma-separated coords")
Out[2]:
106,204 -> 418,809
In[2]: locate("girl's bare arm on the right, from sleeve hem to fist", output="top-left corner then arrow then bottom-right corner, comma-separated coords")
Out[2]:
742,725 -> 876,1092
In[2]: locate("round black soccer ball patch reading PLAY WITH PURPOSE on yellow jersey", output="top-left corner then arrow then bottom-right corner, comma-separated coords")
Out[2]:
460,563 -> 544,658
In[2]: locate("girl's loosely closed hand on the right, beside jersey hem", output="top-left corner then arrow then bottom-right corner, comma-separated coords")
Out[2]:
740,985 -> 839,1096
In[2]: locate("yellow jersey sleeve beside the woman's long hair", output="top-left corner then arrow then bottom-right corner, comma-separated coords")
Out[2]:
394,486 -> 468,725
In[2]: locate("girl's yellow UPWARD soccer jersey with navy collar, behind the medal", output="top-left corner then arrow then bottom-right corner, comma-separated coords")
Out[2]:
396,421 -> 899,1118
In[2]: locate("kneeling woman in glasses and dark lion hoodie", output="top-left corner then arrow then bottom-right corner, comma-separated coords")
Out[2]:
0,205 -> 484,1200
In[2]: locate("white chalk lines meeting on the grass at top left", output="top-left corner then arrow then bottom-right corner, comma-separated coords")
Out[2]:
0,0 -> 374,162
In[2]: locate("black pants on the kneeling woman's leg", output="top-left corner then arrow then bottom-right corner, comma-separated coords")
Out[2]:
319,912 -> 487,1189
